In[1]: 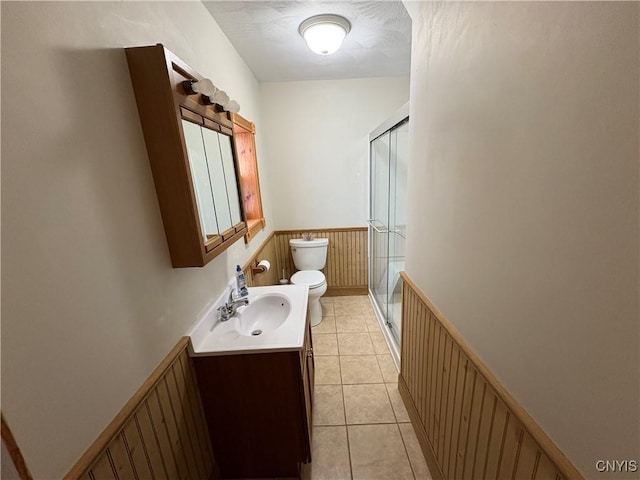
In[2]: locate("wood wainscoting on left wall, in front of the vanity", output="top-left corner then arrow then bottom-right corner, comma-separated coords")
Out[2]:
65,337 -> 218,480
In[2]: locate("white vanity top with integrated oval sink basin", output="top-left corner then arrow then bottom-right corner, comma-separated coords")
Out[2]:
189,285 -> 309,356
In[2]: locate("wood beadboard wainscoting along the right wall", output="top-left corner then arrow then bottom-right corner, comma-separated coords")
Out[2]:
398,272 -> 583,480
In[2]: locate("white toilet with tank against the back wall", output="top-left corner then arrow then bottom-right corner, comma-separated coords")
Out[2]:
289,238 -> 329,327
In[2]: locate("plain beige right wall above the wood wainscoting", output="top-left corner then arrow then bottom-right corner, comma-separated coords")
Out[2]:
407,2 -> 640,478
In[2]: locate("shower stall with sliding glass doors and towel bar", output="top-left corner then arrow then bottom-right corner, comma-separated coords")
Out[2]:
367,104 -> 409,363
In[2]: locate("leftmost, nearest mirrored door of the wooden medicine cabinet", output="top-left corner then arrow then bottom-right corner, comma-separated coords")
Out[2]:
182,120 -> 220,241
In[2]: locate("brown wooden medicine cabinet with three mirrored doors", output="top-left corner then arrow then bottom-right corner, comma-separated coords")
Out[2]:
125,44 -> 248,267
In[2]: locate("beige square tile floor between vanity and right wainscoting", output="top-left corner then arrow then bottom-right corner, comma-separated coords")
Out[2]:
303,296 -> 431,480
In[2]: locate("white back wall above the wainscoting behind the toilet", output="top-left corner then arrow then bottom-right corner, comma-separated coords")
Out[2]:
260,77 -> 409,229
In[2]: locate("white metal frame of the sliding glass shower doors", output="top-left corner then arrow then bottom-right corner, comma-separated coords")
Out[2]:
367,102 -> 409,368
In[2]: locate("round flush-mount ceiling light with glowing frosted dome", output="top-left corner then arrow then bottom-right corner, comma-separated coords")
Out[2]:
298,15 -> 351,55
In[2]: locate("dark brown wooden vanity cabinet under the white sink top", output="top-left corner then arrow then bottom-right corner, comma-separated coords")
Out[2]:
193,319 -> 315,479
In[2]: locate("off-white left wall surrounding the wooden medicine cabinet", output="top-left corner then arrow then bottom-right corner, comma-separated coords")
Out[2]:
2,2 -> 273,478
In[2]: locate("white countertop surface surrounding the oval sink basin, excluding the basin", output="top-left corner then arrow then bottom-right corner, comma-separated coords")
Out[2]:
188,285 -> 309,357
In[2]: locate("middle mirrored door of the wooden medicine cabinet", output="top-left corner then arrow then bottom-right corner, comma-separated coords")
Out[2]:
202,128 -> 237,233
